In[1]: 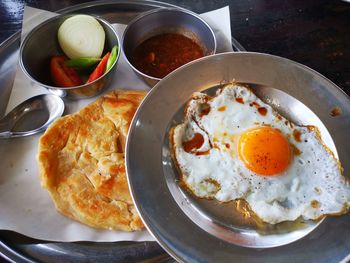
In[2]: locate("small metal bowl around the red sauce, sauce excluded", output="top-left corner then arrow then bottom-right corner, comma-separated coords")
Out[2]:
122,8 -> 216,87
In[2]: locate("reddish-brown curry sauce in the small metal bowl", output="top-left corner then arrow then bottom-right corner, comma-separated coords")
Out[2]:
132,33 -> 204,78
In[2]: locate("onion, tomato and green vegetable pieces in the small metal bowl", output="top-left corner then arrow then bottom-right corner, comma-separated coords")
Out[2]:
50,15 -> 118,87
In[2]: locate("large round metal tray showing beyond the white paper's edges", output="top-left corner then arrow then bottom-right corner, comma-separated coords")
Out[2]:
0,0 -> 244,262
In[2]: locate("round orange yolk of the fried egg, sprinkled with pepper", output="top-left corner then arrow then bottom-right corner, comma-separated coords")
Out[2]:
238,126 -> 292,175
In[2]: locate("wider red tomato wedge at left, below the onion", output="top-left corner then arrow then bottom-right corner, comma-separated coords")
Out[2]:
50,56 -> 83,88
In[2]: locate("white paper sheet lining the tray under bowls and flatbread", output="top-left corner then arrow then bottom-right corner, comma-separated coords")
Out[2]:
0,4 -> 232,242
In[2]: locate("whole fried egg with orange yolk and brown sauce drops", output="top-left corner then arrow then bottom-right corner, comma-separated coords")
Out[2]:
170,84 -> 350,224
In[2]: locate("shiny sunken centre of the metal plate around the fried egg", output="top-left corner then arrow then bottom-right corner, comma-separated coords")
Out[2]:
162,83 -> 330,248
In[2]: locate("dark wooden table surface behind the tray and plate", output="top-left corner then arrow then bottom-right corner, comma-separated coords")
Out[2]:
0,0 -> 350,95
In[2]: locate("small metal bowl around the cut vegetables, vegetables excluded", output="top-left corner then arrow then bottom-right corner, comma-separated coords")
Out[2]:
20,14 -> 120,99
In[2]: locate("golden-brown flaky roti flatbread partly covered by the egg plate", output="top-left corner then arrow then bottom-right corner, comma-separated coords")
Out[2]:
38,90 -> 146,231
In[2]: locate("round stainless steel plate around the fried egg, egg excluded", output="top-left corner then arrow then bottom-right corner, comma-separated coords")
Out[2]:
126,52 -> 350,262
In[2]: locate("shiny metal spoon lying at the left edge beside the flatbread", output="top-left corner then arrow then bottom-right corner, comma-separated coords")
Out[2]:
0,94 -> 64,139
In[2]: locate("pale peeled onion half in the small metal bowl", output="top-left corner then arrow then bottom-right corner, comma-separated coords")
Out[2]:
58,15 -> 105,59
